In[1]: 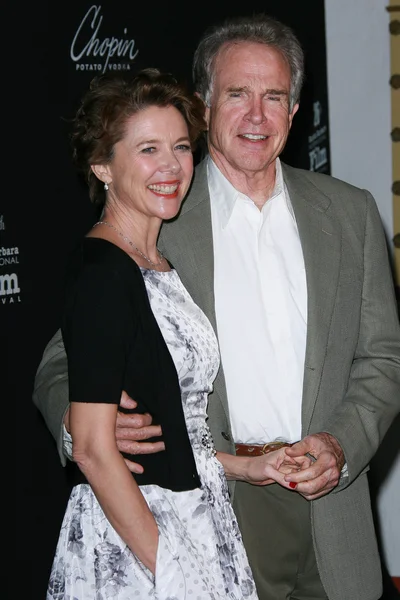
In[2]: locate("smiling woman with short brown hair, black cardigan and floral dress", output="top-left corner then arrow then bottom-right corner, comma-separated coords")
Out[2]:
47,69 -> 307,600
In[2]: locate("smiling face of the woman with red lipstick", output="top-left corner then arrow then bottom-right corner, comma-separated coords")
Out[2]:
103,106 -> 193,219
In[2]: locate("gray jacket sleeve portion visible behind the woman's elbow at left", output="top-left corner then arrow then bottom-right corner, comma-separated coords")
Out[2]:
32,329 -> 69,467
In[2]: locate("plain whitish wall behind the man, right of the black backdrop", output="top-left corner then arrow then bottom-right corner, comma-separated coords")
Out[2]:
325,0 -> 400,577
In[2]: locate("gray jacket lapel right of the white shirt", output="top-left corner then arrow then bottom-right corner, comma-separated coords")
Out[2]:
282,165 -> 341,428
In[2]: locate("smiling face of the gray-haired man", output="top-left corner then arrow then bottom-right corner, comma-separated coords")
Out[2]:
206,42 -> 298,176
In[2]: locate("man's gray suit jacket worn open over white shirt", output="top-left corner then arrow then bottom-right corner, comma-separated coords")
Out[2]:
33,161 -> 400,600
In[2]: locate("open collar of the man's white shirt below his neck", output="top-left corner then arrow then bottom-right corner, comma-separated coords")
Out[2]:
207,156 -> 294,228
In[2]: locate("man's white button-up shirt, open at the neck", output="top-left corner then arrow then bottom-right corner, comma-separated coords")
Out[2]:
208,158 -> 307,444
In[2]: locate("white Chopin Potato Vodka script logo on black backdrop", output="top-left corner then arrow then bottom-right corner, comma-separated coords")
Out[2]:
70,5 -> 139,73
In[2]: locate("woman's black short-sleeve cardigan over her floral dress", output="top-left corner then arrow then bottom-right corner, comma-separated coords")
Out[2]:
61,238 -> 200,491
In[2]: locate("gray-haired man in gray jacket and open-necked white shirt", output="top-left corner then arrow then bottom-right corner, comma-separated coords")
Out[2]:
34,15 -> 400,600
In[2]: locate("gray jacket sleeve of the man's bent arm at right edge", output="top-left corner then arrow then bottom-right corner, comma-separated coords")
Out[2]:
326,192 -> 400,487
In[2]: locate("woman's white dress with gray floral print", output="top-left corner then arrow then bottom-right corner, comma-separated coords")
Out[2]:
47,269 -> 257,600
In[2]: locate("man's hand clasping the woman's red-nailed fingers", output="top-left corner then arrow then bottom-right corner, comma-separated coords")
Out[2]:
285,433 -> 345,500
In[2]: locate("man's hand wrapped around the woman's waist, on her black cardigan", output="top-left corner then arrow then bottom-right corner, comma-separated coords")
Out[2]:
64,392 -> 165,474
